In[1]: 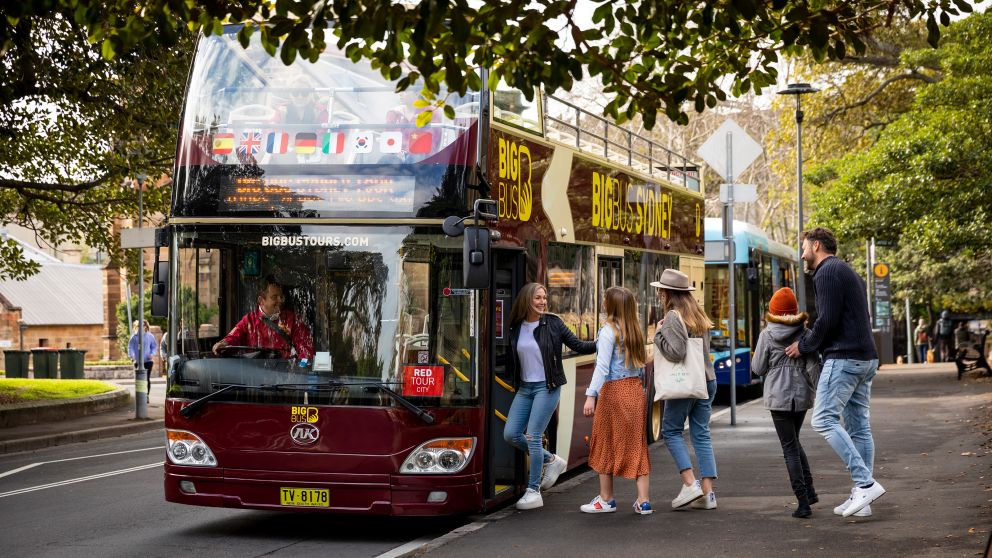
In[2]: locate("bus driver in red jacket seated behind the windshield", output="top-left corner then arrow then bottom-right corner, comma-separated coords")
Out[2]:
213,276 -> 313,360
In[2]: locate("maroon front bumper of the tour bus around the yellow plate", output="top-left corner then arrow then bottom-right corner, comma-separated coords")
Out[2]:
165,465 -> 483,516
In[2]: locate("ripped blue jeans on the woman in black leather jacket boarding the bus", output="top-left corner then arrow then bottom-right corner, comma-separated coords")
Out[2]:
503,382 -> 561,490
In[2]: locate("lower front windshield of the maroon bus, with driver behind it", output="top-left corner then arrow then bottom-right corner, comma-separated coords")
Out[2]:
170,226 -> 477,406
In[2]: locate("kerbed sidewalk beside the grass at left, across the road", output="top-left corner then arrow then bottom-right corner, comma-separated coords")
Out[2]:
0,378 -> 165,453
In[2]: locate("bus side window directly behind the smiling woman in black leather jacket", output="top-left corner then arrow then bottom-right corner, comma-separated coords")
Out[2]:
547,242 -> 597,348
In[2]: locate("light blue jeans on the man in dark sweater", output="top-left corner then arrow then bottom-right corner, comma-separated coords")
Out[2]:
812,358 -> 878,486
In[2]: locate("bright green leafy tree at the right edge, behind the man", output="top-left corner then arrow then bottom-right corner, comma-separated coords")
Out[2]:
808,10 -> 992,311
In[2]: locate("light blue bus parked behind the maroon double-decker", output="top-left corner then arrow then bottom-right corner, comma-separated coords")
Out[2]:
705,218 -> 797,386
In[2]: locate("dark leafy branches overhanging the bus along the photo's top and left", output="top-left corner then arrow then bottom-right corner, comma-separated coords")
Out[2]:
0,0 -> 976,277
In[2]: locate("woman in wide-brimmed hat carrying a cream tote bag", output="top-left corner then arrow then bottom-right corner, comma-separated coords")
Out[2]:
651,269 -> 717,510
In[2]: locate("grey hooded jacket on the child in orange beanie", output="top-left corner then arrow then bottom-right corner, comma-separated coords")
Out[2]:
751,312 -> 819,411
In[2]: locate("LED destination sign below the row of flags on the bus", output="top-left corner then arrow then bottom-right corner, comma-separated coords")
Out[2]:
218,175 -> 416,214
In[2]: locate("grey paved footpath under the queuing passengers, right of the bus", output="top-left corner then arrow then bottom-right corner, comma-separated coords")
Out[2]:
420,364 -> 992,558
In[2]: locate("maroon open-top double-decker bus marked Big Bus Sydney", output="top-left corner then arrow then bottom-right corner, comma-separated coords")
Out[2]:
153,27 -> 704,515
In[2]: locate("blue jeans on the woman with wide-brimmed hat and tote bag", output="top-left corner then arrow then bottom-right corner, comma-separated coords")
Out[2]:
661,380 -> 716,479
